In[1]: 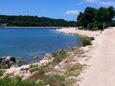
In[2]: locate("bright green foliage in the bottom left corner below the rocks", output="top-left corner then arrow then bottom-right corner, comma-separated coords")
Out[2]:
0,76 -> 45,86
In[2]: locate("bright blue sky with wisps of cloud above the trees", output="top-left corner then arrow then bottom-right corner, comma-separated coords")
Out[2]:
0,0 -> 115,20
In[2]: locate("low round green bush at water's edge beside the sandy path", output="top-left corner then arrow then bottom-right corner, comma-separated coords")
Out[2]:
80,37 -> 94,47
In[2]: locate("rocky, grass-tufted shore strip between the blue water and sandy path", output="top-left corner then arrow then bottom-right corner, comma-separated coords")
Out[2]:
0,29 -> 100,86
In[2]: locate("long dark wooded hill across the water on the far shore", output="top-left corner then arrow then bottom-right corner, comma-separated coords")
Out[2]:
0,15 -> 76,27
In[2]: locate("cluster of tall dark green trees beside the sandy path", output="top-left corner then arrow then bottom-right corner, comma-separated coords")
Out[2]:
77,6 -> 115,30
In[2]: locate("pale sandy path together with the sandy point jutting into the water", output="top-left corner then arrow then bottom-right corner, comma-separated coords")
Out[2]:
58,27 -> 115,86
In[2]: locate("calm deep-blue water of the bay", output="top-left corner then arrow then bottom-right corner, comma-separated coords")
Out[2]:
0,28 -> 79,62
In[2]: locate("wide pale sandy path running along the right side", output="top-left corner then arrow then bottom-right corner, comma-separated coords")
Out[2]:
80,28 -> 115,86
